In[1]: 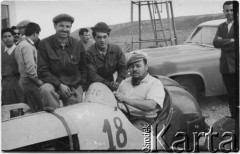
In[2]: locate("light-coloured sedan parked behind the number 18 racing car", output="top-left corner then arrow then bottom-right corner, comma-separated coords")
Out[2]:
128,19 -> 226,98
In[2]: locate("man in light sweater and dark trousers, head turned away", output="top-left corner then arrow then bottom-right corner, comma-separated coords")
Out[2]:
15,22 -> 43,112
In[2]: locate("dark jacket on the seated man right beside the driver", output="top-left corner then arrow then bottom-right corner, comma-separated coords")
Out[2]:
87,44 -> 127,86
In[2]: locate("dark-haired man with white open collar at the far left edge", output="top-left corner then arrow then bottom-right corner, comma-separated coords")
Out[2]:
2,28 -> 23,105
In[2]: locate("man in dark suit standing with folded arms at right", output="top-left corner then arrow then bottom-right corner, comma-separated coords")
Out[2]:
213,1 -> 238,118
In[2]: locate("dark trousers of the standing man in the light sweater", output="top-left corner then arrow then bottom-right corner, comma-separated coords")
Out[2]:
19,77 -> 43,113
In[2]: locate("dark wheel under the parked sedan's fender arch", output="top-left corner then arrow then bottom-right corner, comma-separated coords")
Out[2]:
174,77 -> 199,100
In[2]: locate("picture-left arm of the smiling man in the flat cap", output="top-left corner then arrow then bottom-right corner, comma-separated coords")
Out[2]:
38,42 -> 61,90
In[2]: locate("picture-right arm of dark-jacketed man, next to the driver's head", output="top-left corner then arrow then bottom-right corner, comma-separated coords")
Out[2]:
116,47 -> 127,83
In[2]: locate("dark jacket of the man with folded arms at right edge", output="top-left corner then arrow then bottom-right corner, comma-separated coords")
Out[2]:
213,22 -> 236,73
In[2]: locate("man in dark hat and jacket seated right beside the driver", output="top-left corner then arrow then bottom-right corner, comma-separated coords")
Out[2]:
87,22 -> 127,91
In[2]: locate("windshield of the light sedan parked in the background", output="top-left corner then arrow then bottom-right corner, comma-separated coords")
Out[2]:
187,26 -> 217,46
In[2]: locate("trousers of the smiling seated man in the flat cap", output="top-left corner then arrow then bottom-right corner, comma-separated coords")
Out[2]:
40,83 -> 83,109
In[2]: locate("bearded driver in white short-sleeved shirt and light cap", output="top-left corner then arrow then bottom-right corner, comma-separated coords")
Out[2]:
114,53 -> 165,129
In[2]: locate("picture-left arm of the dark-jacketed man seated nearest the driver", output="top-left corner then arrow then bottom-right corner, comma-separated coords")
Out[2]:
87,53 -> 110,87
